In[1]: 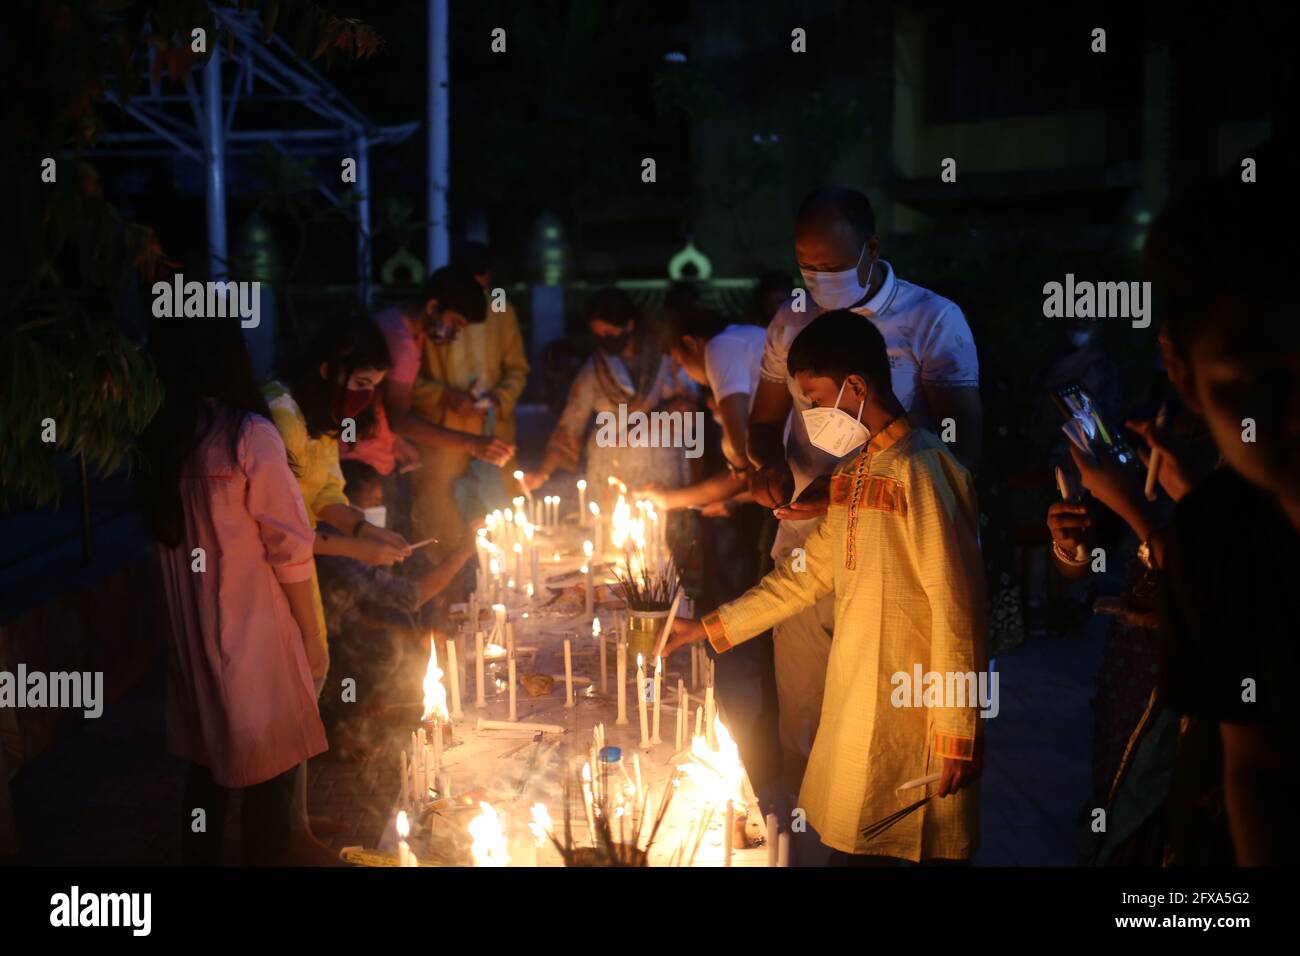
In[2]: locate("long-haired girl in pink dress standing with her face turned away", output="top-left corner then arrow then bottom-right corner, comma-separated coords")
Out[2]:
140,319 -> 326,864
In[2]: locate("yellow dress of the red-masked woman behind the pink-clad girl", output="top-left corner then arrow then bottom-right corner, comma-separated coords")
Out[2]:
265,382 -> 351,680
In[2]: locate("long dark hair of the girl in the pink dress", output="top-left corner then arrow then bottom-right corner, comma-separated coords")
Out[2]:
137,319 -> 270,548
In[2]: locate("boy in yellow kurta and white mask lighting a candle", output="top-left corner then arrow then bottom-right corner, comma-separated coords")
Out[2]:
668,310 -> 992,861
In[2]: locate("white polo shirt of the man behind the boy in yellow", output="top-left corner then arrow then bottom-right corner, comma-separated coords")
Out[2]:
761,259 -> 979,559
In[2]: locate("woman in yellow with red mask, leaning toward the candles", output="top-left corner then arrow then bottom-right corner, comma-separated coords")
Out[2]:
265,317 -> 411,858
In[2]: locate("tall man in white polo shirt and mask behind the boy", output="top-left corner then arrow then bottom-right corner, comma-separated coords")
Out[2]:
749,187 -> 983,793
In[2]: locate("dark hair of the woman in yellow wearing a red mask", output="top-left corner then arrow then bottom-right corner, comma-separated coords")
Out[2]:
281,316 -> 390,438
